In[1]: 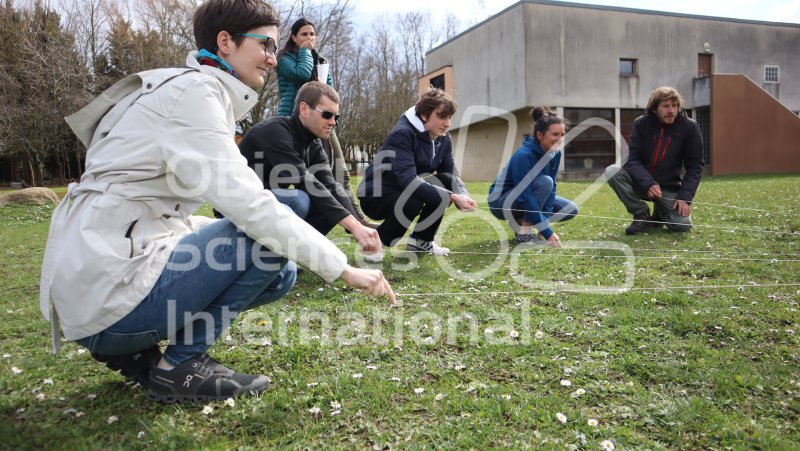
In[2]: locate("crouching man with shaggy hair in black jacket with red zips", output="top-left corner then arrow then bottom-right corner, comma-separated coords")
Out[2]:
606,87 -> 703,235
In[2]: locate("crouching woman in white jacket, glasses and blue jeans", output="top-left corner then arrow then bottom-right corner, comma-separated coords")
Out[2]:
41,0 -> 394,402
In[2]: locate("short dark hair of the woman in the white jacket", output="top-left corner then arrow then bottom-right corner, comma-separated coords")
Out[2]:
192,0 -> 280,53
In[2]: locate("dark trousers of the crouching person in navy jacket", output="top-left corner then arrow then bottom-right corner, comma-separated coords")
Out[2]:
359,174 -> 453,246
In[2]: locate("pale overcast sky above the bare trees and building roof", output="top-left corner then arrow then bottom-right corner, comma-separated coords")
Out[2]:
351,0 -> 800,29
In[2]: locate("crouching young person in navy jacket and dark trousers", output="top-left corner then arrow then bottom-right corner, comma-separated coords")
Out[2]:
358,88 -> 477,261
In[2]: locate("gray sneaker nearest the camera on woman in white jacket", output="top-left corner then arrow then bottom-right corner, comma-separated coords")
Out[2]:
147,354 -> 270,404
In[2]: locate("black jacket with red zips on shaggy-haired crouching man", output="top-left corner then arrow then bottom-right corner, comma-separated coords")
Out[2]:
624,110 -> 703,202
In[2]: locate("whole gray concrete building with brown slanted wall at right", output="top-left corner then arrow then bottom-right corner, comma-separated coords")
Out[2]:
420,0 -> 800,180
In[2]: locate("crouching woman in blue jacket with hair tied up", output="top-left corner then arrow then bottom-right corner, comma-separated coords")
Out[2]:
489,107 -> 578,247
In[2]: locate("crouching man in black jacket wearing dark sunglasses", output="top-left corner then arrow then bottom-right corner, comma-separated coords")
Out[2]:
239,82 -> 382,254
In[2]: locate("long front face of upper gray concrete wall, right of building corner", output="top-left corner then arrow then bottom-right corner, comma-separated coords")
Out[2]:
518,3 -> 800,109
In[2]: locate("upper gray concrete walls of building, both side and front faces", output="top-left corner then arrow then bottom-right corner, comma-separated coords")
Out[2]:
427,0 -> 800,129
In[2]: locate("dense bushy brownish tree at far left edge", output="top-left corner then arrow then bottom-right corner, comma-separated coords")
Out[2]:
0,0 -> 87,185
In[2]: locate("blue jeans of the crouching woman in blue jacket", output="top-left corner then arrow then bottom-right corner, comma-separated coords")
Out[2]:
489,176 -> 578,232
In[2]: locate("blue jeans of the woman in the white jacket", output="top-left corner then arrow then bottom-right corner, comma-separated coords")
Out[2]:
77,219 -> 297,365
